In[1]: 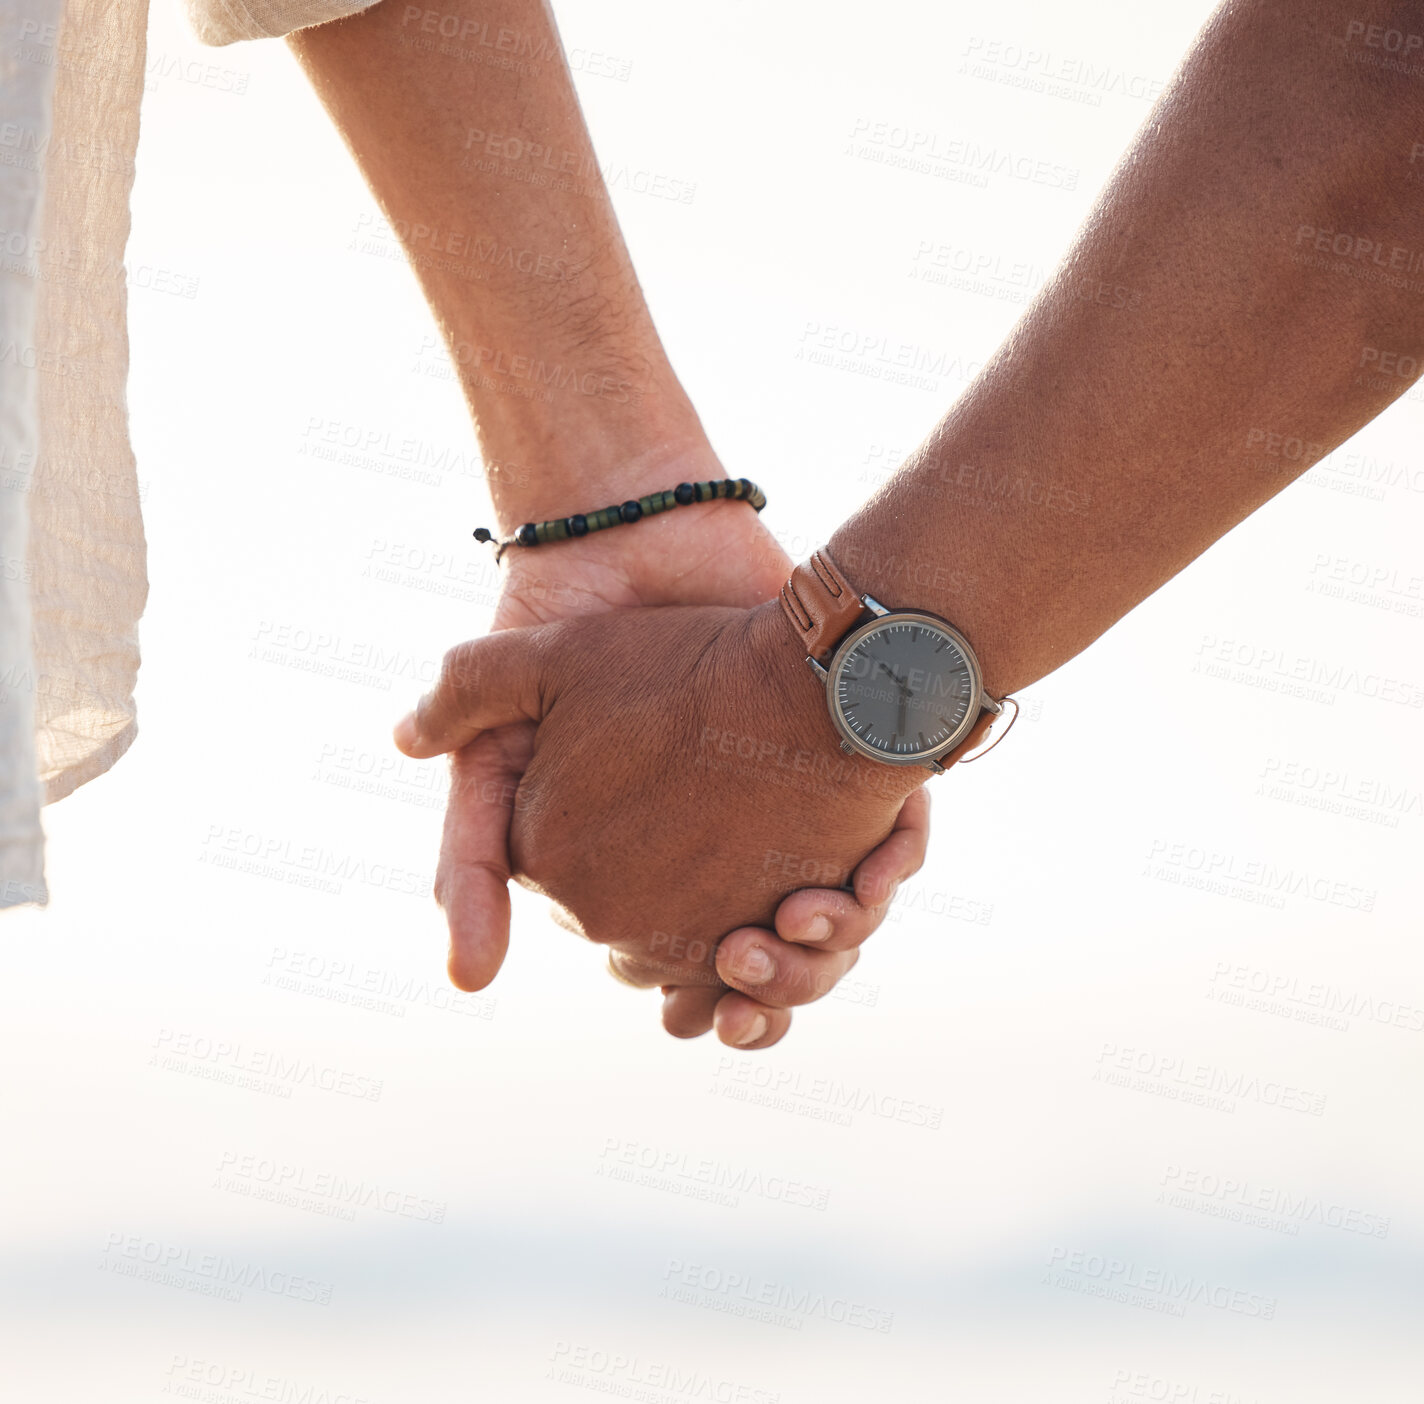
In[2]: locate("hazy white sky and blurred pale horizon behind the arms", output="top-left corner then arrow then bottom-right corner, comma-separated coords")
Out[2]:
0,0 -> 1424,1404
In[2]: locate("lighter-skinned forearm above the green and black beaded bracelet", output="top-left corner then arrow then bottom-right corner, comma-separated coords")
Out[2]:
290,0 -> 701,528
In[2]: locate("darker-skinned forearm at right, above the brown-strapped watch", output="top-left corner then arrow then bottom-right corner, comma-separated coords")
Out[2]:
832,0 -> 1424,691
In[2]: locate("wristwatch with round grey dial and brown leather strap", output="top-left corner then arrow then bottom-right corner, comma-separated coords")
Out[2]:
782,547 -> 1018,775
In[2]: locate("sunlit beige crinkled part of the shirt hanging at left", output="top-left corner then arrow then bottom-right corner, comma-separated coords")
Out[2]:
28,0 -> 148,802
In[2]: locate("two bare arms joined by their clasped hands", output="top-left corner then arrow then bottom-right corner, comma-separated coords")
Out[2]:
292,0 -> 1424,1048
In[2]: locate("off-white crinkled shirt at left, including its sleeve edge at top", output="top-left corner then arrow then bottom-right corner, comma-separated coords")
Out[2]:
0,0 -> 376,907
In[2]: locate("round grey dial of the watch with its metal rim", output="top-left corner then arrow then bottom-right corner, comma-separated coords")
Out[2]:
829,612 -> 981,765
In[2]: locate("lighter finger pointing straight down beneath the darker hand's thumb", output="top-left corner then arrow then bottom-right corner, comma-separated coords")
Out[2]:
436,722 -> 534,990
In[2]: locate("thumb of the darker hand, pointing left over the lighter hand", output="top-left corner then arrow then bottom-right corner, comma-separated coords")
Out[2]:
394,628 -> 561,760
